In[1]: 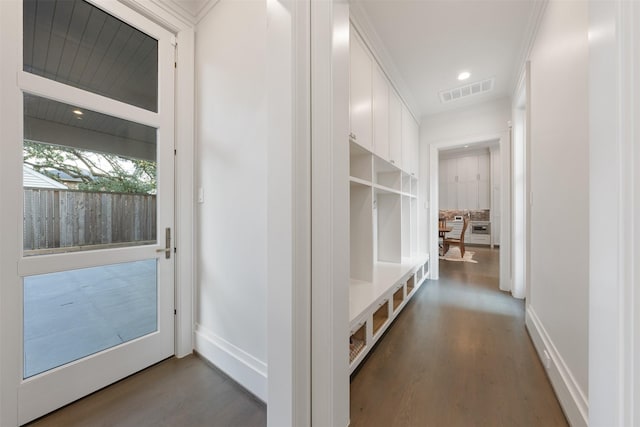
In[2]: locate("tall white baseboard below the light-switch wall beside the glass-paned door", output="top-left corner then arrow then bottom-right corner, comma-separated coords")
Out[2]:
195,325 -> 267,403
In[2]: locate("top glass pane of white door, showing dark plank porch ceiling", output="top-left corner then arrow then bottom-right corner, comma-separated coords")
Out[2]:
23,0 -> 158,112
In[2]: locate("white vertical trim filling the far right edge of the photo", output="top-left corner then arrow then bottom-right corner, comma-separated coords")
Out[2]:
589,0 -> 640,427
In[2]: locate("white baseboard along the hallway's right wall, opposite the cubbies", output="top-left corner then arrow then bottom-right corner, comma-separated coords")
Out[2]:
525,306 -> 589,427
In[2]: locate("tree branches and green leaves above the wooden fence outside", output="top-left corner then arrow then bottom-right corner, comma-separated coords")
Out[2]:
23,141 -> 156,194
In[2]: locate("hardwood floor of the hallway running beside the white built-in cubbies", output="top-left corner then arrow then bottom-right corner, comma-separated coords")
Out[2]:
351,247 -> 567,427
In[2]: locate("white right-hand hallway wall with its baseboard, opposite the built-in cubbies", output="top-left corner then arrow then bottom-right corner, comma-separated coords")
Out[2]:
527,0 -> 589,426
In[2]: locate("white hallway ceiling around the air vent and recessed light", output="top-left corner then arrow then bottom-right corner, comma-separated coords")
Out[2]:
351,0 -> 542,116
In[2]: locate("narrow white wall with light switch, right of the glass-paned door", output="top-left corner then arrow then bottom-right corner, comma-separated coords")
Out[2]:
195,0 -> 267,400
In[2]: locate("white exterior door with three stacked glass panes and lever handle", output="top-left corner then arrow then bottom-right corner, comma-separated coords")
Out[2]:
3,0 -> 175,424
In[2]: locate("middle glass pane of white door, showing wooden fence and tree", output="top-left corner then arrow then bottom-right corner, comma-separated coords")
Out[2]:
23,94 -> 157,256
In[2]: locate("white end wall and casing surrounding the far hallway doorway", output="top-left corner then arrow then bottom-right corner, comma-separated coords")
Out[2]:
419,98 -> 511,282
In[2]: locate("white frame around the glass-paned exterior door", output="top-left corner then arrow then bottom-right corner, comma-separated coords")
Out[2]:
0,0 -> 195,426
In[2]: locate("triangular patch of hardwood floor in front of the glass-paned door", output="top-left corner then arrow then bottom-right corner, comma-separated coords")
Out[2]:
29,356 -> 267,427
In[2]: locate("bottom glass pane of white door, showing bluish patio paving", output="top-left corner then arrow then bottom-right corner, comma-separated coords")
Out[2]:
23,258 -> 158,378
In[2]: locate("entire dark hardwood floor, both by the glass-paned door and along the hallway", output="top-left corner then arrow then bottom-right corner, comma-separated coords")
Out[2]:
31,248 -> 567,427
